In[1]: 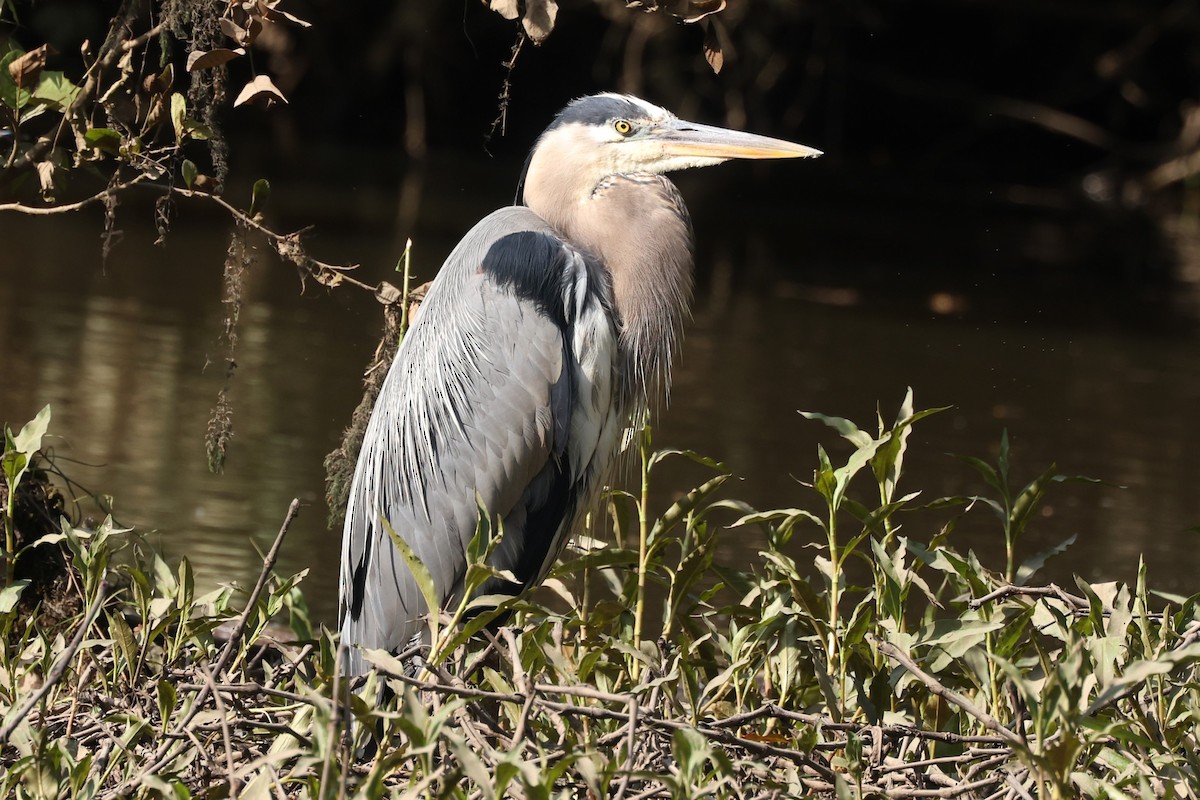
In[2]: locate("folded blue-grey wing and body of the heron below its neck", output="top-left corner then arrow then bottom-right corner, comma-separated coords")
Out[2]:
341,207 -> 620,672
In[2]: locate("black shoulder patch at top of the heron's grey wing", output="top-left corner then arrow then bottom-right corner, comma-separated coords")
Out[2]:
481,230 -> 571,327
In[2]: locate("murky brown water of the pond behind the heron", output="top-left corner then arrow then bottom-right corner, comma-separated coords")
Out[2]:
0,159 -> 1200,619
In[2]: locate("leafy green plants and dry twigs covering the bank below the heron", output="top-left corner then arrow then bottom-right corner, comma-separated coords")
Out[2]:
0,395 -> 1200,798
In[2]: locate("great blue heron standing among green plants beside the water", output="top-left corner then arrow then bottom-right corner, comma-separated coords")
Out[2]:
340,94 -> 821,674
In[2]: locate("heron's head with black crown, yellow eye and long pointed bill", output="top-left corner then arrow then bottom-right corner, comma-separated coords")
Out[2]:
518,94 -> 821,206
